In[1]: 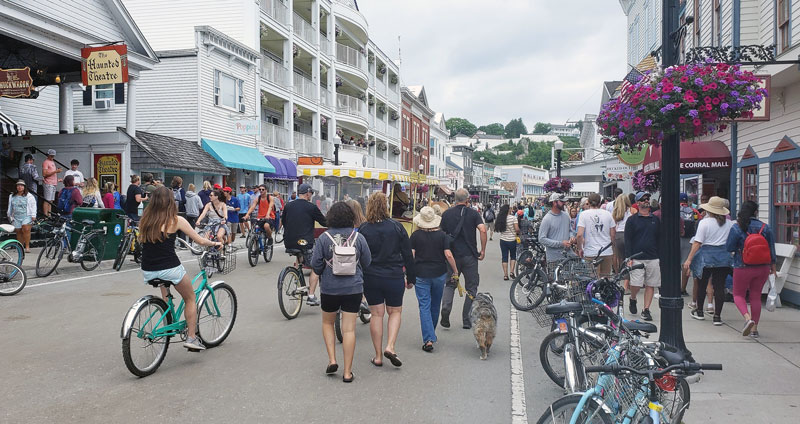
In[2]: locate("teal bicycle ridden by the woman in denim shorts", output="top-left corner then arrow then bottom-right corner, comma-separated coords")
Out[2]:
120,240 -> 237,377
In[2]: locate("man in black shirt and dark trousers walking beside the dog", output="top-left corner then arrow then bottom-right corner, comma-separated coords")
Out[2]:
441,188 -> 487,329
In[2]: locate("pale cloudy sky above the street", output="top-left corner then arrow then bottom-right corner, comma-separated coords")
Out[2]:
358,0 -> 627,129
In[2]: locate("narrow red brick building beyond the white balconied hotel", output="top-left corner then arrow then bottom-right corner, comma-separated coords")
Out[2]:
400,85 -> 434,174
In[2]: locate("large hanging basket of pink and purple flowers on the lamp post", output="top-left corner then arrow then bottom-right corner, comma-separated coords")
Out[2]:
597,62 -> 767,150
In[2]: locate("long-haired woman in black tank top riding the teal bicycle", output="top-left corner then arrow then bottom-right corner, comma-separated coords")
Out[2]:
139,186 -> 224,350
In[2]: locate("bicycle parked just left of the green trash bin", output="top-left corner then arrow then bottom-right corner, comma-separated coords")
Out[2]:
36,217 -> 106,277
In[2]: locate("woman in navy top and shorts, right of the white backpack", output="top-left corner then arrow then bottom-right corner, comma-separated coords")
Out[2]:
360,192 -> 416,367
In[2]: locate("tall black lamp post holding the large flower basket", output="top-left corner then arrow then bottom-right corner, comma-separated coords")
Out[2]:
658,0 -> 691,355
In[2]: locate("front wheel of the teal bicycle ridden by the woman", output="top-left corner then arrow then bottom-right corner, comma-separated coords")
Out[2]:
197,283 -> 237,347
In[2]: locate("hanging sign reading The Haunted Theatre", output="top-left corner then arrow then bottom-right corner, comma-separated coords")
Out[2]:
81,44 -> 128,87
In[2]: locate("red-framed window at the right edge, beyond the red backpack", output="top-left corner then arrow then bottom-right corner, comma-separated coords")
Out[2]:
772,159 -> 800,245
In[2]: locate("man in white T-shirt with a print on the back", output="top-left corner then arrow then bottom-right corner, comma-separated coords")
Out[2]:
577,193 -> 616,276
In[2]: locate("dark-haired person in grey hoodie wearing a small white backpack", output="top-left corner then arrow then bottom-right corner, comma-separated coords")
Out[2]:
312,200 -> 372,383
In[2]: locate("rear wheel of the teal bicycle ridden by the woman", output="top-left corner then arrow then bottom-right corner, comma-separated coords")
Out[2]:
122,297 -> 172,377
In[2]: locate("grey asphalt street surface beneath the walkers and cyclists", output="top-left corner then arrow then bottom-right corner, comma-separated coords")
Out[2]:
0,240 -> 561,423
